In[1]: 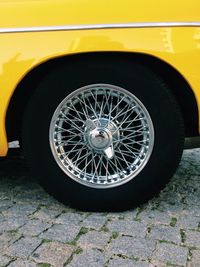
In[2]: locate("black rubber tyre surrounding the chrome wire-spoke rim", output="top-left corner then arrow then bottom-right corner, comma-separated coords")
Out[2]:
23,58 -> 184,210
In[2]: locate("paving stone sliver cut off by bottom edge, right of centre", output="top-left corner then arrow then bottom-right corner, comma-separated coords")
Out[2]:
107,258 -> 151,267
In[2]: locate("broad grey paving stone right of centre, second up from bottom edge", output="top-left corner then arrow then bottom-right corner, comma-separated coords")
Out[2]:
108,236 -> 156,260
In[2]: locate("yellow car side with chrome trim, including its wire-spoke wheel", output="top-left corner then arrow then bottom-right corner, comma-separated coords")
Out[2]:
0,0 -> 200,210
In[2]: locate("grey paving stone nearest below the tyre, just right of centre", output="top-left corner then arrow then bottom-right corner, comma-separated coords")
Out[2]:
106,219 -> 147,238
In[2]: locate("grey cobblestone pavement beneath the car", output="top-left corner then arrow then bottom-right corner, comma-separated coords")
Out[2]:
0,149 -> 200,267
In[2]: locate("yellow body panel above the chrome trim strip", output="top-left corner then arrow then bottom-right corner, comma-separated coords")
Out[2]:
0,0 -> 200,27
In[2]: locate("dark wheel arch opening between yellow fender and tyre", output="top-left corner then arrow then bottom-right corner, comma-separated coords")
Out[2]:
6,52 -> 199,144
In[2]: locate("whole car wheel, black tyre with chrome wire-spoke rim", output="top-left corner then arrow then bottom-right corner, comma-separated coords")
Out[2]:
22,59 -> 184,211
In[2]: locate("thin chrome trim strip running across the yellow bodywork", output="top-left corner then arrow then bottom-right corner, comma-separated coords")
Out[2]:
0,22 -> 200,33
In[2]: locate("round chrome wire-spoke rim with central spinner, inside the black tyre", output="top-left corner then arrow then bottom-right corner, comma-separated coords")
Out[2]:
49,84 -> 154,189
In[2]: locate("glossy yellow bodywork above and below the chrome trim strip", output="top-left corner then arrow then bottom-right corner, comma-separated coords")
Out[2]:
0,0 -> 200,156
